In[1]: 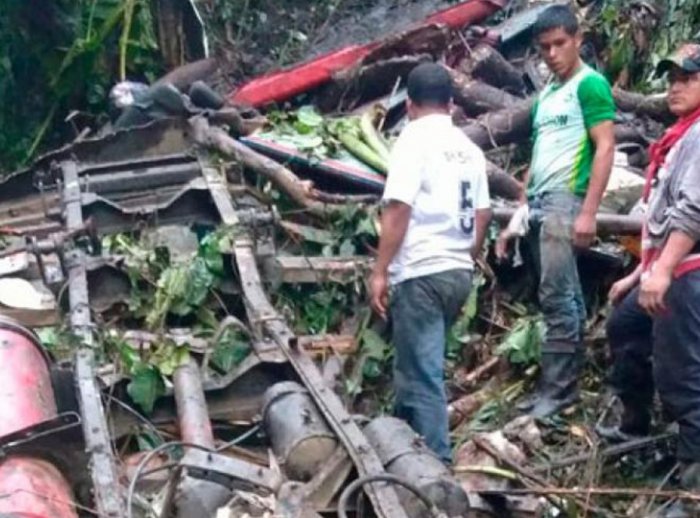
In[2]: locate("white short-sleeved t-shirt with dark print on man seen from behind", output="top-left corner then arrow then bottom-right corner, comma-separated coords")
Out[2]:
383,114 -> 491,284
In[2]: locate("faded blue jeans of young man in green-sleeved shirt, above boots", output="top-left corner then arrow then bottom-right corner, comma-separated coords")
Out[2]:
528,192 -> 586,353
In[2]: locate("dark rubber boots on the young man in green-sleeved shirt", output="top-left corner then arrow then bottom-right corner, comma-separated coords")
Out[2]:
529,351 -> 583,419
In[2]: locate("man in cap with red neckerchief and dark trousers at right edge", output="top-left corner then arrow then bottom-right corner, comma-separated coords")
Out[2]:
599,44 -> 700,516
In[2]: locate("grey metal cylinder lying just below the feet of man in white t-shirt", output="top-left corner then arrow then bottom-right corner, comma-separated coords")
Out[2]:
364,417 -> 469,518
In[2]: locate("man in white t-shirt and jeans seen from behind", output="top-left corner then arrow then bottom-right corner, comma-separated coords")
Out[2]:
370,63 -> 491,462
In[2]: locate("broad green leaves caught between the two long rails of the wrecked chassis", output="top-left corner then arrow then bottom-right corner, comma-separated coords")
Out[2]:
101,227 -> 245,413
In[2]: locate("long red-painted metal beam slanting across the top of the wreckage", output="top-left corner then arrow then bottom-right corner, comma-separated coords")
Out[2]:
230,0 -> 506,106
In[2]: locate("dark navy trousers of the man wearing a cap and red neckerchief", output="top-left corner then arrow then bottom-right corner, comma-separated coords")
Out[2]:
607,271 -> 700,462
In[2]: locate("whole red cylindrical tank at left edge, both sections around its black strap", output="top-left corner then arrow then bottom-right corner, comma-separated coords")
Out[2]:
0,317 -> 78,518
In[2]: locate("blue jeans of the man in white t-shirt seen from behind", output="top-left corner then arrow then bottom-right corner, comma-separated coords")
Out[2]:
389,270 -> 472,463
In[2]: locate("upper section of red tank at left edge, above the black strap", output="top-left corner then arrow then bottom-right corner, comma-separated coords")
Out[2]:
0,317 -> 58,437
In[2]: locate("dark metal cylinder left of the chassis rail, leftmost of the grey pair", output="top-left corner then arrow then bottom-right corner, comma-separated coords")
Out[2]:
263,381 -> 338,482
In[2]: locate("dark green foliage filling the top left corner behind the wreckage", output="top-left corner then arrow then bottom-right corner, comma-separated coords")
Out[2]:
0,0 -> 161,175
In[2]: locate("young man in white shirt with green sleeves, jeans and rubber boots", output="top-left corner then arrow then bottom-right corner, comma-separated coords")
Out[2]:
508,5 -> 615,418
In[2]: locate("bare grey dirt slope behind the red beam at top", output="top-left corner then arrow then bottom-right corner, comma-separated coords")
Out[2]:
202,0 -> 455,82
